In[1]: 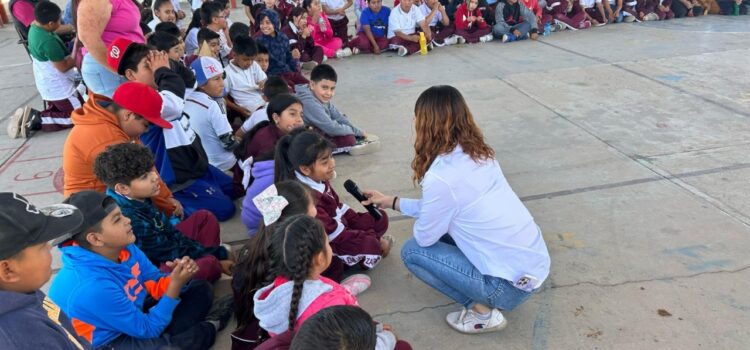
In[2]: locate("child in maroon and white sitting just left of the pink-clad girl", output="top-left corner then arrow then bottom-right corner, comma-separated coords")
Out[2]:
281,7 -> 325,70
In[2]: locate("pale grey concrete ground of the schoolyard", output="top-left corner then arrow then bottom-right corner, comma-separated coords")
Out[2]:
0,6 -> 750,349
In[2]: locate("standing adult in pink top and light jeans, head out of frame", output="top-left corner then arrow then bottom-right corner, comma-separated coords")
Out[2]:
77,0 -> 146,98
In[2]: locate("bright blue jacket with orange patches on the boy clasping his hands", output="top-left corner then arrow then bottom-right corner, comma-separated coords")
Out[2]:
49,244 -> 180,347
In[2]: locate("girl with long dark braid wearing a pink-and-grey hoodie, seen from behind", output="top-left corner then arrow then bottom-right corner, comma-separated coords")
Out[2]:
253,214 -> 376,337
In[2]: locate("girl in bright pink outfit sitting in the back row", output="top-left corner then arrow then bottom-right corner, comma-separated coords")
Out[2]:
302,0 -> 352,58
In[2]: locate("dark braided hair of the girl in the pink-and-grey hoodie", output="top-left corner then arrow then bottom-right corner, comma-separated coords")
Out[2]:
271,214 -> 326,330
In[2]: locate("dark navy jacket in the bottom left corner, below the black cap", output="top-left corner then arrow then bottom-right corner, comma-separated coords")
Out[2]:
0,290 -> 91,350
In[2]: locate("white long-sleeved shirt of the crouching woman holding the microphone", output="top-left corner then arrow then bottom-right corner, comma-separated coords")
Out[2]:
399,146 -> 550,288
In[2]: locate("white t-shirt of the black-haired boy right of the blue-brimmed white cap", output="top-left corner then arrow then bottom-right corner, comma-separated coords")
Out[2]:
224,62 -> 267,111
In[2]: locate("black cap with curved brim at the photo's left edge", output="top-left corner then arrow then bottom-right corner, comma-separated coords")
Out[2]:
0,192 -> 83,259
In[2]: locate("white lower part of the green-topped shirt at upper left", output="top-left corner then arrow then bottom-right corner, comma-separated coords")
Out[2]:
31,57 -> 78,101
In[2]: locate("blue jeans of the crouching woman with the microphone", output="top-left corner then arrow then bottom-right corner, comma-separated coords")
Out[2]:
401,235 -> 534,310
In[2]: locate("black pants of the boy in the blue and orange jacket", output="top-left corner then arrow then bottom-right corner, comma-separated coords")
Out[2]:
100,281 -> 216,350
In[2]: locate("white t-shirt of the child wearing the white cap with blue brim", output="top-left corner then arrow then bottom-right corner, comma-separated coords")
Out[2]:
185,91 -> 237,171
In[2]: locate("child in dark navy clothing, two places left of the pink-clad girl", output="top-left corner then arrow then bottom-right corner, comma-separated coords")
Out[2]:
257,9 -> 309,88
